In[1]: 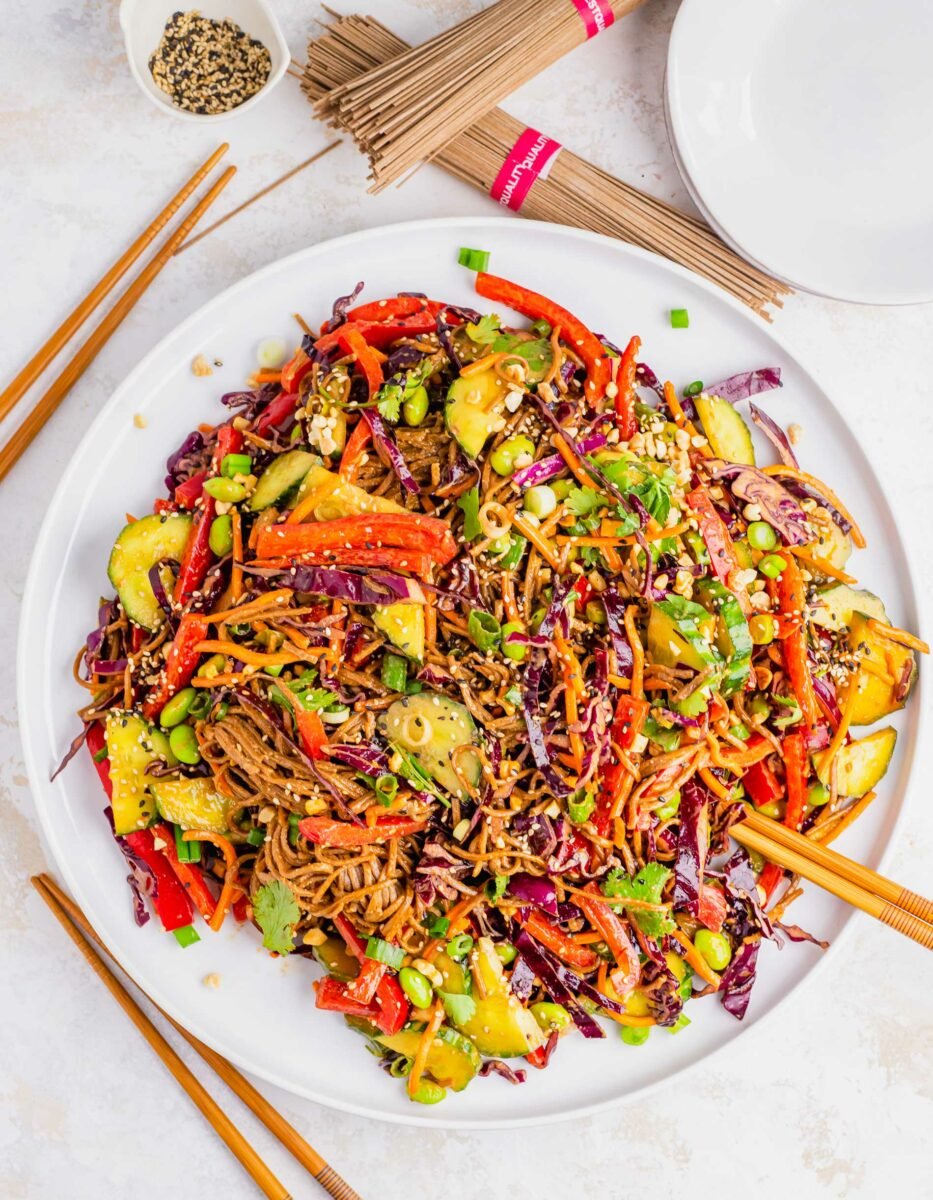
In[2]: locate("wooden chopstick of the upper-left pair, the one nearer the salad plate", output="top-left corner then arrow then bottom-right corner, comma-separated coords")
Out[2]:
0,167 -> 236,480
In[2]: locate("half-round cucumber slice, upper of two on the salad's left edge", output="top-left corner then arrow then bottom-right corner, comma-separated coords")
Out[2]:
107,512 -> 192,629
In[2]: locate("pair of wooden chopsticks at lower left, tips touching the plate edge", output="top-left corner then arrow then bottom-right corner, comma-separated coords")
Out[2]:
32,875 -> 360,1200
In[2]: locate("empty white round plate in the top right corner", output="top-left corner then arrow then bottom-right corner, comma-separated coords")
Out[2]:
666,0 -> 933,304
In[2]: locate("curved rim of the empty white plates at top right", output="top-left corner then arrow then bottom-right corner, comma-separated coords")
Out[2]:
662,0 -> 933,308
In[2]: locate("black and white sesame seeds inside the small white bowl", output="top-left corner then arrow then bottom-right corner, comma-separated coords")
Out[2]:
149,10 -> 272,116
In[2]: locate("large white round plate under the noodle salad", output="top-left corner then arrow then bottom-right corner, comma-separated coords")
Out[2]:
19,218 -> 919,1127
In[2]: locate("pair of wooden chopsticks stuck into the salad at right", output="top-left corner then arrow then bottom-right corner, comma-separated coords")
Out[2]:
729,809 -> 933,950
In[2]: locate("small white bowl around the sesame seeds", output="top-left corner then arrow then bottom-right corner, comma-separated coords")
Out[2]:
120,0 -> 291,121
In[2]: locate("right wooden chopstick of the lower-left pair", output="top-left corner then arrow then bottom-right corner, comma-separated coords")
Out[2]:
32,875 -> 360,1200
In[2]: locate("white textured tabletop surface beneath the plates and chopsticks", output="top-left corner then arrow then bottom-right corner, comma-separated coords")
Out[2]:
0,0 -> 933,1200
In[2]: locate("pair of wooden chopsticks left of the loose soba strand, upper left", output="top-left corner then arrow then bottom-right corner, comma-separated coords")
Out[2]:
0,142 -> 236,480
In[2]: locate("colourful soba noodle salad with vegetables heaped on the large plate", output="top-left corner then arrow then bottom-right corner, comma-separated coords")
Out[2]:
71,252 -> 923,1104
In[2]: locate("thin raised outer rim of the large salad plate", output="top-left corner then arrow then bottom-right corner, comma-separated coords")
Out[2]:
17,216 -> 926,1130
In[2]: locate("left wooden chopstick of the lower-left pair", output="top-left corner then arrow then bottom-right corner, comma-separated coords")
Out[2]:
32,876 -> 291,1200
